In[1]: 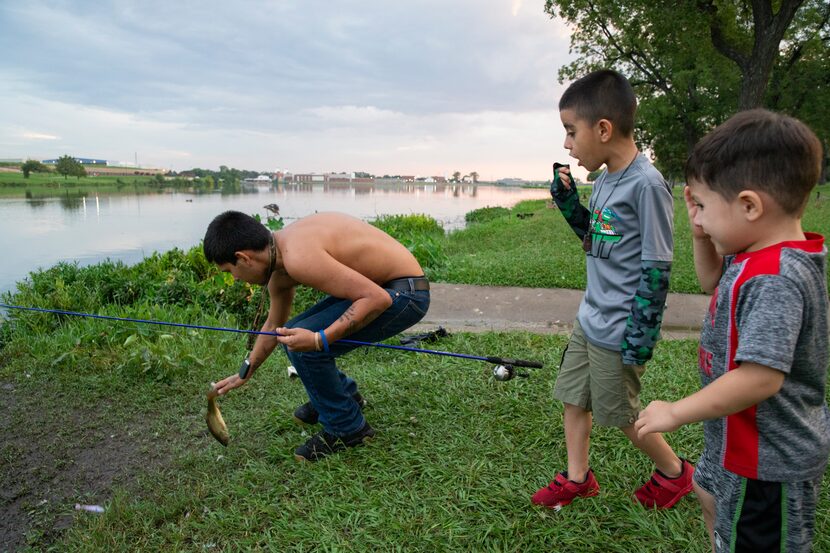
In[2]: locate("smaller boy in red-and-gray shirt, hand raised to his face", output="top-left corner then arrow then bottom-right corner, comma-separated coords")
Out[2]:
635,109 -> 830,553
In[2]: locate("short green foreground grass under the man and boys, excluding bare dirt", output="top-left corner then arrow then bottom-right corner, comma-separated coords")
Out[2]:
0,322 -> 830,553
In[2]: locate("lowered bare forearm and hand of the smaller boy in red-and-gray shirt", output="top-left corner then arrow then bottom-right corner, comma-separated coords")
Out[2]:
634,362 -> 786,438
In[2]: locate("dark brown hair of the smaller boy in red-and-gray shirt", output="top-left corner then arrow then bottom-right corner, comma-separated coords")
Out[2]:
686,109 -> 822,215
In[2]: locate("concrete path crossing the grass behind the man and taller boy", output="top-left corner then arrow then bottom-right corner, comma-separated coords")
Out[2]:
412,283 -> 709,339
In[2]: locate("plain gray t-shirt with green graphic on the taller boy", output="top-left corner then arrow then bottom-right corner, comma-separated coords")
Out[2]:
577,154 -> 674,351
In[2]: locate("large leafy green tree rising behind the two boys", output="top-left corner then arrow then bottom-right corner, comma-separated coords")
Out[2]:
545,0 -> 830,177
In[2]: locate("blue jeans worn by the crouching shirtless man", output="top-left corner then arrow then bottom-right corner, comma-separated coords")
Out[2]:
285,290 -> 429,436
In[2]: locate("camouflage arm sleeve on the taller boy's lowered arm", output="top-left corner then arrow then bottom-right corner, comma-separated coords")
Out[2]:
620,261 -> 671,365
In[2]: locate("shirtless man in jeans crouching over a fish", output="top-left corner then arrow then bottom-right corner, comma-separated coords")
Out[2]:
204,211 -> 430,461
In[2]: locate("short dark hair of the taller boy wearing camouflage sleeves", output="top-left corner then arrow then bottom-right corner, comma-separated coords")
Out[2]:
559,69 -> 637,136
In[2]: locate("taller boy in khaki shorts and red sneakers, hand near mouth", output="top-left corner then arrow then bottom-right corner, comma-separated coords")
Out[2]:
531,71 -> 694,510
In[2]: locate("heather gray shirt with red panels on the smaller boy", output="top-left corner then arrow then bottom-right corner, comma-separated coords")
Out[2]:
698,233 -> 830,482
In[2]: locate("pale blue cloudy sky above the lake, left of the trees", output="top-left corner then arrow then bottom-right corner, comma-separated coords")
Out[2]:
0,0 -> 571,180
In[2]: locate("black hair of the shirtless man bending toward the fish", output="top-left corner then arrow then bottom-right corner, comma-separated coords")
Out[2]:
202,211 -> 268,265
